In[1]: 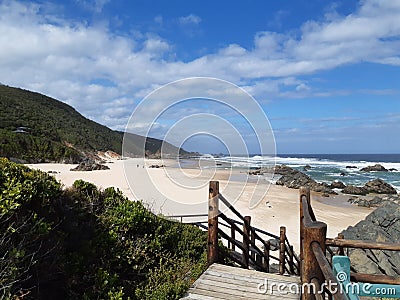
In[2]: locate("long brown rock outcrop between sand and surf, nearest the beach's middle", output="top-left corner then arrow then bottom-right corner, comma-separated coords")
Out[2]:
274,165 -> 337,195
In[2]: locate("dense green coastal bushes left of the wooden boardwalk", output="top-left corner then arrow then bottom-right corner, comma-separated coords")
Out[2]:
0,158 -> 207,299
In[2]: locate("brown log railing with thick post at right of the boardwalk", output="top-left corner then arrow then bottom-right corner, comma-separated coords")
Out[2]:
300,188 -> 400,300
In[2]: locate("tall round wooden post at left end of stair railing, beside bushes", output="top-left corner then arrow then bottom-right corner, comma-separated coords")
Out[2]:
207,181 -> 219,266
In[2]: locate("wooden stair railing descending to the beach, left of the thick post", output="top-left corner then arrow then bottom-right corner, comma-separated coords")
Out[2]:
207,181 -> 300,275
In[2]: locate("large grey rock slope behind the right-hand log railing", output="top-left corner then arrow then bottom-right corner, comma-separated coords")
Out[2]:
342,201 -> 400,276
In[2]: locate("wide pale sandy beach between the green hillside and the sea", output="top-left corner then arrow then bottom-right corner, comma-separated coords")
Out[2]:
28,159 -> 373,250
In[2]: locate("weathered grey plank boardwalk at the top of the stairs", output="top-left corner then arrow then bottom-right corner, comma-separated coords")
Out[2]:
181,264 -> 301,300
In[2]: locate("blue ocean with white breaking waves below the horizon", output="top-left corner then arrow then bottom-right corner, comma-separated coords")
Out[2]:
203,154 -> 400,192
